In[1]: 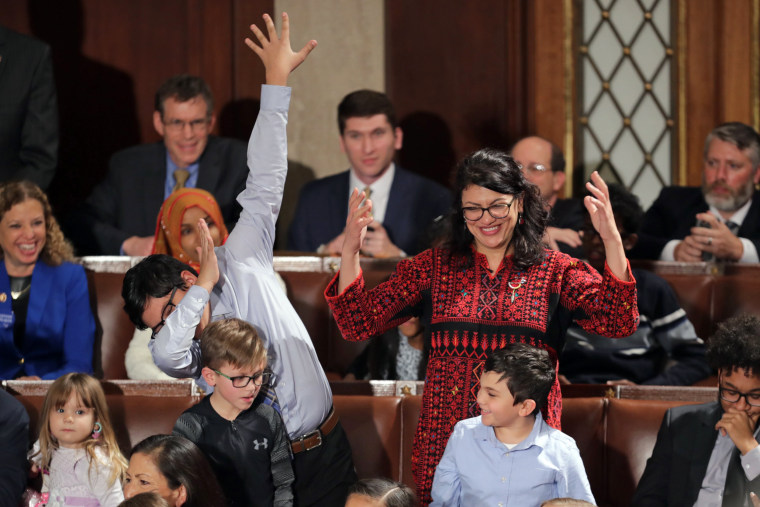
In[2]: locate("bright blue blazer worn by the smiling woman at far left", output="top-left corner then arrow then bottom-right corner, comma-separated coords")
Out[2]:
0,261 -> 95,380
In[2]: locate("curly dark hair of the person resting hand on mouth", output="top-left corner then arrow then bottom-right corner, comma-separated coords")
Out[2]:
707,314 -> 760,375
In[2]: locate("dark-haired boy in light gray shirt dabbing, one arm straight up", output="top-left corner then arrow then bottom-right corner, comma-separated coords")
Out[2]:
122,14 -> 357,507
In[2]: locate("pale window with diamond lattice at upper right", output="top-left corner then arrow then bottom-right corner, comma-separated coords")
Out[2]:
575,0 -> 676,209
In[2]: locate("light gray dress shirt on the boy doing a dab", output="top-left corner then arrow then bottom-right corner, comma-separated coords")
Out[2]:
151,85 -> 332,439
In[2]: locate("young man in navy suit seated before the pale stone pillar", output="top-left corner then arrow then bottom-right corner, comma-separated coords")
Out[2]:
288,90 -> 452,257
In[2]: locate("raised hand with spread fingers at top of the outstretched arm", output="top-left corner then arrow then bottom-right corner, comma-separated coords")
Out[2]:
245,12 -> 317,86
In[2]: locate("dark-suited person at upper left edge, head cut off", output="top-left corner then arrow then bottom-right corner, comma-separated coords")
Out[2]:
0,26 -> 58,190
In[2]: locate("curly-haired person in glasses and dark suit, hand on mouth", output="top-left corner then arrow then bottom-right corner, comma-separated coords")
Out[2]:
631,315 -> 760,507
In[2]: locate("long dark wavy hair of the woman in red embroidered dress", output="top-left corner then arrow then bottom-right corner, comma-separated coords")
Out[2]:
445,148 -> 549,269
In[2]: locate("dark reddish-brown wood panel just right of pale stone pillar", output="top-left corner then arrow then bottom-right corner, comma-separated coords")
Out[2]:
386,0 -> 527,188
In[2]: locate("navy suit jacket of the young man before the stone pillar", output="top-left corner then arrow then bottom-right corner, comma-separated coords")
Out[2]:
288,165 -> 452,255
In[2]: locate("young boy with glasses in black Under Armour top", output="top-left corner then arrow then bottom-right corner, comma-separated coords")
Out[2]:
174,319 -> 293,506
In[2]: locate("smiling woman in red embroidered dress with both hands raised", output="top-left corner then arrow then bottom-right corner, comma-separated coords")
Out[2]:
325,150 -> 638,505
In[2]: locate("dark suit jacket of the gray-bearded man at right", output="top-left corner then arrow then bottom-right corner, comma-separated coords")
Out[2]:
629,187 -> 760,260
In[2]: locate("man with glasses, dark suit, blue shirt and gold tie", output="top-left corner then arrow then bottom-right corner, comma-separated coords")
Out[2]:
69,75 -> 248,255
